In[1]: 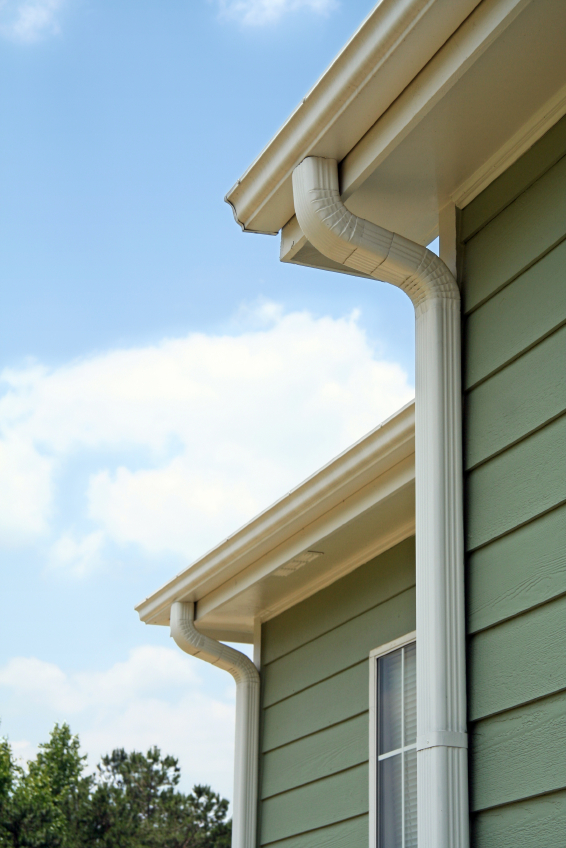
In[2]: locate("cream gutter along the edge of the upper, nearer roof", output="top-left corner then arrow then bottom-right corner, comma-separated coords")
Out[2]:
226,0 -> 480,234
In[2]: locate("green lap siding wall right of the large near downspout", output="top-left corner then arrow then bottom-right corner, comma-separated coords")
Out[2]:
460,114 -> 566,848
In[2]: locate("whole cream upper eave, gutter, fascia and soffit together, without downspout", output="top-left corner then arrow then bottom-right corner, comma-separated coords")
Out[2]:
226,0 -> 566,258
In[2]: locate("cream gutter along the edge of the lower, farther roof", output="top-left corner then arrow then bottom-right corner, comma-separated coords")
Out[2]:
136,402 -> 415,624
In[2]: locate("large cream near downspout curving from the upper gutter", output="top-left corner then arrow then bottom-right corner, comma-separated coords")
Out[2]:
293,157 -> 469,848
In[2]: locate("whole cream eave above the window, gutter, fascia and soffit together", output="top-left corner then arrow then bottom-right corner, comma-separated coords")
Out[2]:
136,403 -> 415,642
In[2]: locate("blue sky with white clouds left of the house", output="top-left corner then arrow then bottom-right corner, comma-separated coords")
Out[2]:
0,0 -> 414,797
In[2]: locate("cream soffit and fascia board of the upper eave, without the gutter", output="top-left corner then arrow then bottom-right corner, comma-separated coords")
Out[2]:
341,0 -> 566,244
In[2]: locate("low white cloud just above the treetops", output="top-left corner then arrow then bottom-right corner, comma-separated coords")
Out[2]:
0,645 -> 234,797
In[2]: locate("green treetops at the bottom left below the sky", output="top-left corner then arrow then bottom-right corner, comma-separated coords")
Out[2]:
0,724 -> 231,848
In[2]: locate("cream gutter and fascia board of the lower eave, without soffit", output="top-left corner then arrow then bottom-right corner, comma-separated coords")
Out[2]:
136,401 -> 415,641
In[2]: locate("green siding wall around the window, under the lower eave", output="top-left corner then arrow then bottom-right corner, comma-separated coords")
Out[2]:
259,538 -> 415,848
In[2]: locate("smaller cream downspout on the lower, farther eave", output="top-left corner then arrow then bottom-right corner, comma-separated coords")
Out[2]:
170,601 -> 259,848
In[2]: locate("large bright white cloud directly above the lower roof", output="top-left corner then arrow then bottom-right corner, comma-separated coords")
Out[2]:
0,304 -> 413,575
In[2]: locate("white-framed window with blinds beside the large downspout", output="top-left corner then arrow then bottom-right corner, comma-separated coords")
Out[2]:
370,633 -> 417,848
